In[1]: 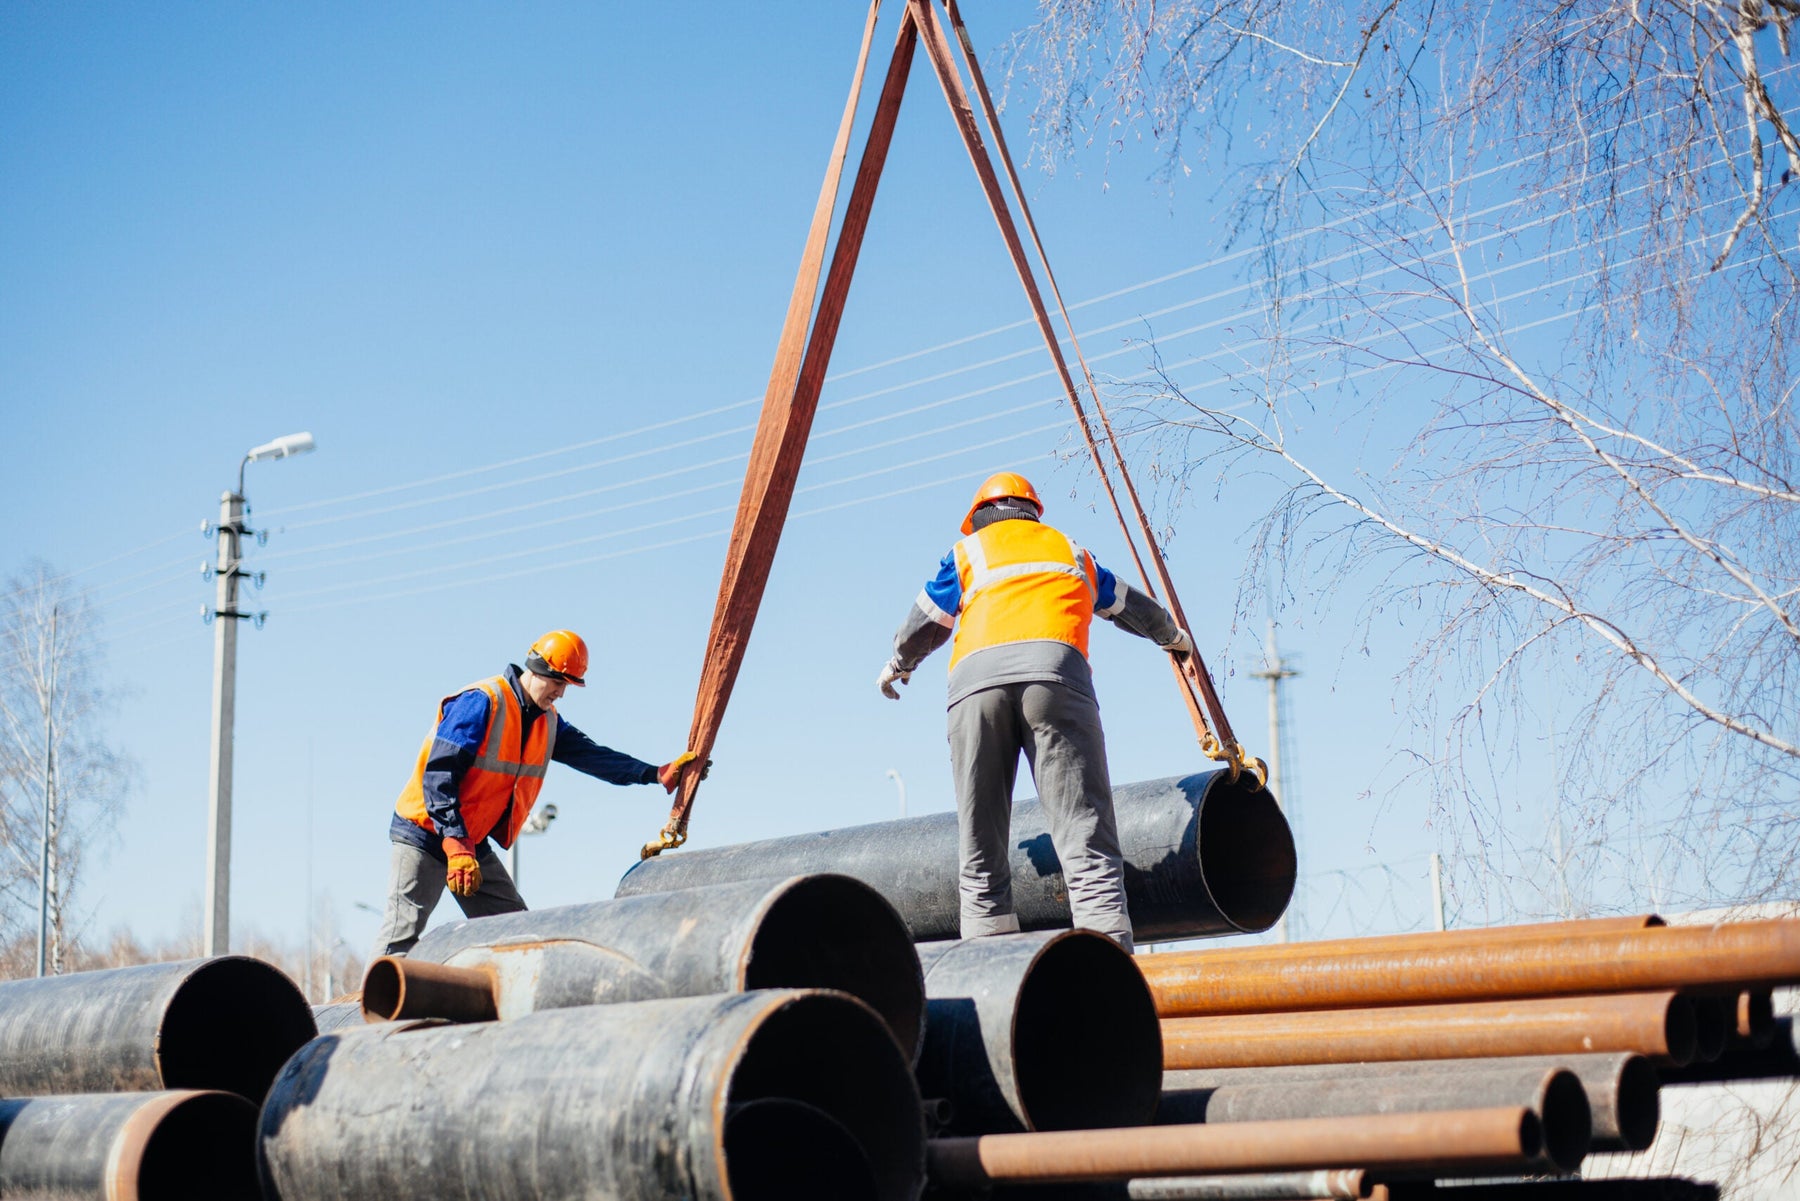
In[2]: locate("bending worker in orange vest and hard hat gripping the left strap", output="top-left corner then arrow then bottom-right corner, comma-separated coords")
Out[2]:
376,630 -> 711,954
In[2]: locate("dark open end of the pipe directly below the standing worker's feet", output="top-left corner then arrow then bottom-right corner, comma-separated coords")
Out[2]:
1013,929 -> 1163,1131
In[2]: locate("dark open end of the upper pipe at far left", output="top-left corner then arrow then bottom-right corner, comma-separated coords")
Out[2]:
157,954 -> 319,1104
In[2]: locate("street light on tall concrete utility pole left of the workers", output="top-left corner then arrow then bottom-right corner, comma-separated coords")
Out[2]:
203,434 -> 313,956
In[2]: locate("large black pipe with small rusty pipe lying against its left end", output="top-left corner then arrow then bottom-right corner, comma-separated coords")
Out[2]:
399,873 -> 925,1055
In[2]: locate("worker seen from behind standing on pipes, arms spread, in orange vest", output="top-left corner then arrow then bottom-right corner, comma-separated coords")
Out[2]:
875,472 -> 1193,949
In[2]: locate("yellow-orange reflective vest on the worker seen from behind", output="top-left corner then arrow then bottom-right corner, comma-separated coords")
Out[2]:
950,519 -> 1098,672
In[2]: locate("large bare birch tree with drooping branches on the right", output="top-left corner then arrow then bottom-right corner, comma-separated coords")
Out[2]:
1010,0 -> 1800,920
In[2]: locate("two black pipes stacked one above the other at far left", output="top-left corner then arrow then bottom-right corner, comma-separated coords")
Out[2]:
0,956 -> 315,1201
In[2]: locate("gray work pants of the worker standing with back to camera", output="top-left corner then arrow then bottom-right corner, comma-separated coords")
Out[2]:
950,681 -> 1132,951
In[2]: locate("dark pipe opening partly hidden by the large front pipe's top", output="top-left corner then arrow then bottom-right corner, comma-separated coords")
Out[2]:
743,873 -> 925,1059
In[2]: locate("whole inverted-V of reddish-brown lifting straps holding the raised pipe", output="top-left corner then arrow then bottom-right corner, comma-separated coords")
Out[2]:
643,0 -> 1267,859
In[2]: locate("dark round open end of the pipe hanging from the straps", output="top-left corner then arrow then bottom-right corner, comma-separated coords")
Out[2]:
1195,772 -> 1300,935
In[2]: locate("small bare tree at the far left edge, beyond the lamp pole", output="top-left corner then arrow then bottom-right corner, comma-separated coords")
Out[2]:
0,562 -> 131,971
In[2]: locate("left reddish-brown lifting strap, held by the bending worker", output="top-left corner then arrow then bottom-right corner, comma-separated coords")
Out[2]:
643,0 -> 918,857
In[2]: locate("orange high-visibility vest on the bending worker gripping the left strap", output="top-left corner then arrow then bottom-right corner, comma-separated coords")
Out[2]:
394,675 -> 556,846
